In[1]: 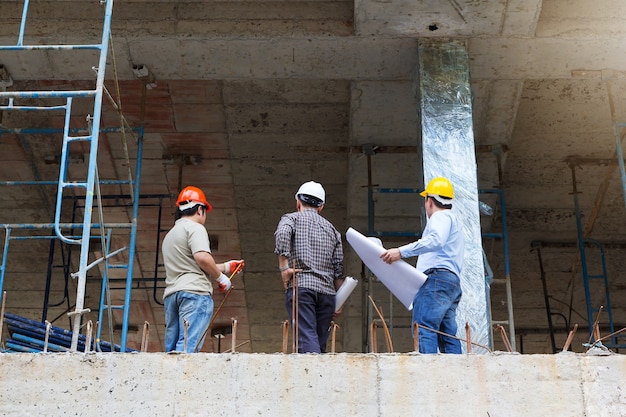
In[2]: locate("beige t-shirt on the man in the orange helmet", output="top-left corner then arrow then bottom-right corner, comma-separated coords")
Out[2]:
162,217 -> 213,299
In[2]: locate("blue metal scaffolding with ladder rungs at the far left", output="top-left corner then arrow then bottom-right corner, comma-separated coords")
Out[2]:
0,0 -> 143,351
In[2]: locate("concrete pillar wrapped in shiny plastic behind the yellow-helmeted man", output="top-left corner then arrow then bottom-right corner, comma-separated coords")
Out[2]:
415,39 -> 490,352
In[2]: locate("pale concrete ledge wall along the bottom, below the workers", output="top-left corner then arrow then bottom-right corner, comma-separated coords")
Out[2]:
0,353 -> 626,417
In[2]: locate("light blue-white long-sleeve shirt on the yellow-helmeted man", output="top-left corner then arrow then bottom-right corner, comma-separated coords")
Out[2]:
399,210 -> 465,276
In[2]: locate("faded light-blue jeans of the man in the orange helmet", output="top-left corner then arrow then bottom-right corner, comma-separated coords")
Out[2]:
163,291 -> 213,353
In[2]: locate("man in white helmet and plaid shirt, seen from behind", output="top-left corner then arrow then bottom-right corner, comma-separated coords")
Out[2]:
274,181 -> 344,353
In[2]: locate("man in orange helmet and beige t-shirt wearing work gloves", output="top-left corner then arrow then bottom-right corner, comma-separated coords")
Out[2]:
162,186 -> 244,352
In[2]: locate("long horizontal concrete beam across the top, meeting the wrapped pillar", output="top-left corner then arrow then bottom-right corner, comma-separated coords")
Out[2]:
0,36 -> 626,82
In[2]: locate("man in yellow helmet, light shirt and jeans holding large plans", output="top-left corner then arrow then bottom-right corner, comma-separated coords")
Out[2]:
380,177 -> 465,353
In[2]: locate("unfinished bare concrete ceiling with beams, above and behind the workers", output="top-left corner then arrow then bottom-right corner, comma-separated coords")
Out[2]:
0,0 -> 626,351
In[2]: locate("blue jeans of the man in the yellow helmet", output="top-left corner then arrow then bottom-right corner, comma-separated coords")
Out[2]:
413,269 -> 462,353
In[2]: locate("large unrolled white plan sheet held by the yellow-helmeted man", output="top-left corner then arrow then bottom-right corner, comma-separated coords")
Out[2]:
346,227 -> 427,310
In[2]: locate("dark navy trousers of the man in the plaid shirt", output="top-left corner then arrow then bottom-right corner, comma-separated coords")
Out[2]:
285,288 -> 335,353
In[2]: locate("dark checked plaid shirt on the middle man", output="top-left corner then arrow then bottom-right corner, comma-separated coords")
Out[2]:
274,209 -> 343,295
